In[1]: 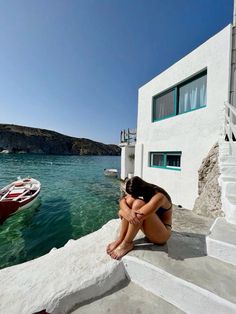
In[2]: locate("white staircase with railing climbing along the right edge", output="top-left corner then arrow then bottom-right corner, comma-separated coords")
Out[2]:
206,103 -> 236,265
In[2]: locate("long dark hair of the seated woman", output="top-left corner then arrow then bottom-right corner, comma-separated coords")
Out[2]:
125,176 -> 171,203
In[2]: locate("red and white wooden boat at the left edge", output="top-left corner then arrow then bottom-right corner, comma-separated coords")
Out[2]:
0,178 -> 41,223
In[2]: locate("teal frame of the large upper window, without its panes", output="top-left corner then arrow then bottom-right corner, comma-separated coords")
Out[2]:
152,69 -> 207,122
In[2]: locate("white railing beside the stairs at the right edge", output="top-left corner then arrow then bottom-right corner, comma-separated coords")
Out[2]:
225,102 -> 236,148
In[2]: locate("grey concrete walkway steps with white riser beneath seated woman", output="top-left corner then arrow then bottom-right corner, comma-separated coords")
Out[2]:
73,208 -> 236,314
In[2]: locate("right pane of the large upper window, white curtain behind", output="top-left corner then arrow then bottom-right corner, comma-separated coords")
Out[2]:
179,74 -> 207,113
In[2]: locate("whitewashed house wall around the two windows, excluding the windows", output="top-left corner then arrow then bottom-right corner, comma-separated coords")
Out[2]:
135,25 -> 231,209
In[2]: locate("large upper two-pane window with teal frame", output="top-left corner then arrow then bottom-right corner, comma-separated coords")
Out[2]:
152,71 -> 207,122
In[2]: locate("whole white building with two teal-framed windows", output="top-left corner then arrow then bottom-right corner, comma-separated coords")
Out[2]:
121,25 -> 232,209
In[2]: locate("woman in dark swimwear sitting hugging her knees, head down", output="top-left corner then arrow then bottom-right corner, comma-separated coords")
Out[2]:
107,176 -> 172,259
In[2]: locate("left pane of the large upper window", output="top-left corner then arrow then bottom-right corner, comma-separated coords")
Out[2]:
153,90 -> 175,120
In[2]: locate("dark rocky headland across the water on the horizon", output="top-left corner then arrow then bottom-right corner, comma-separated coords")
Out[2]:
0,124 -> 120,155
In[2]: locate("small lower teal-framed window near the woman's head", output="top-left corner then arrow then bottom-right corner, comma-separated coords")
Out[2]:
149,152 -> 181,170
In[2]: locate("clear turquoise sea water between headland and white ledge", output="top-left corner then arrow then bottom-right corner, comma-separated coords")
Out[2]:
0,154 -> 120,268
